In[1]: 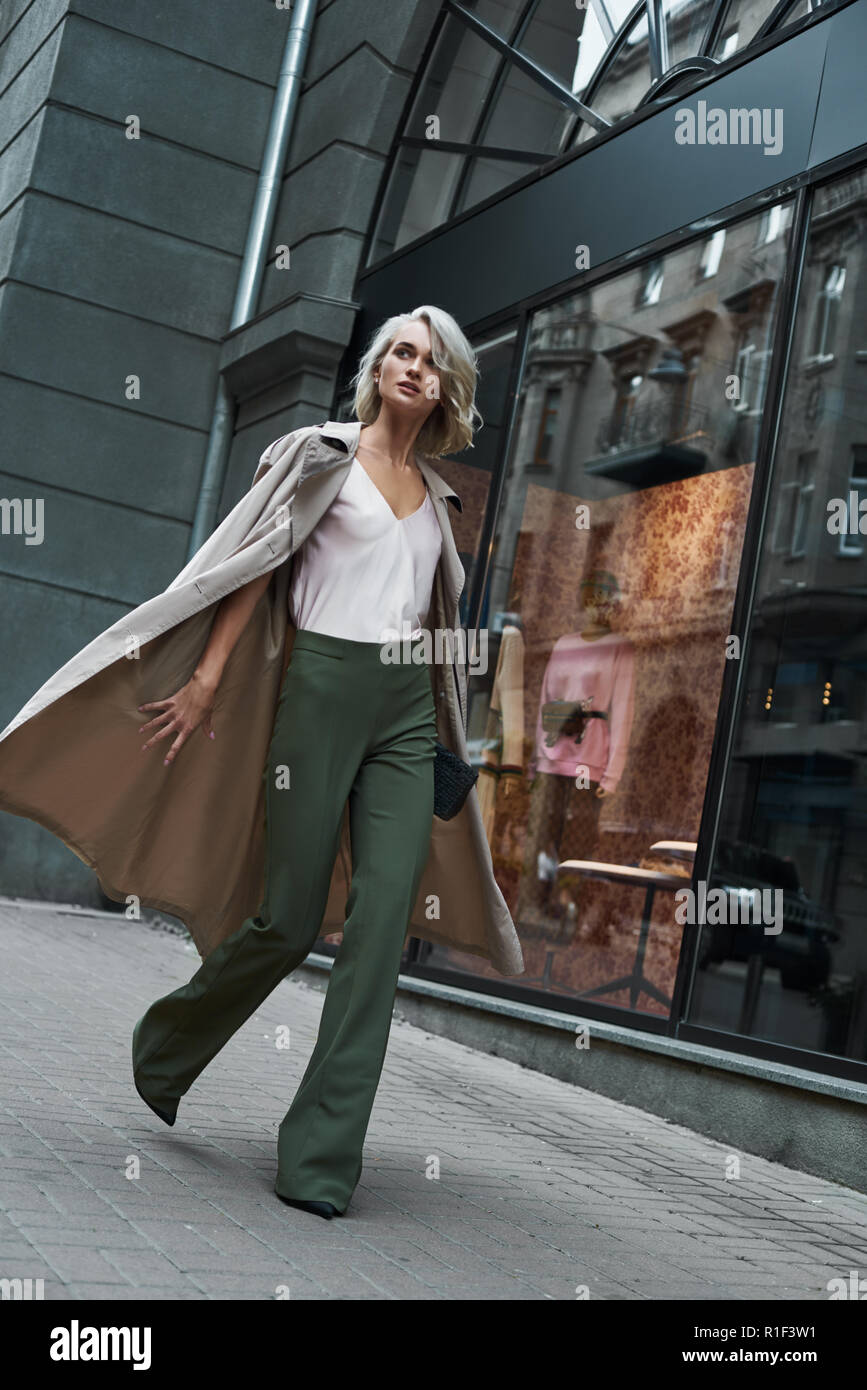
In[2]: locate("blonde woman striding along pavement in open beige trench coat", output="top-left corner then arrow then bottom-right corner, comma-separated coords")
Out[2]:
0,306 -> 522,1218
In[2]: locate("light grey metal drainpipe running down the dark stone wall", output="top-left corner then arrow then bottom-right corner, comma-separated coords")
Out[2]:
186,0 -> 317,560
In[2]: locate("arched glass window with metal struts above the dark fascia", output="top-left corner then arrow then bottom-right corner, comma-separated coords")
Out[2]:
368,0 -> 834,264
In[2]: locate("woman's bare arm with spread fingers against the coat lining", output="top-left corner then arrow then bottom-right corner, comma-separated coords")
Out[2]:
139,570 -> 271,763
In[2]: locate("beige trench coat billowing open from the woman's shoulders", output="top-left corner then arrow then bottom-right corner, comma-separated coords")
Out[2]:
0,421 -> 524,976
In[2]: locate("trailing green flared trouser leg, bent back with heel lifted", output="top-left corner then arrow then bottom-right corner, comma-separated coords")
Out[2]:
132,631 -> 369,1115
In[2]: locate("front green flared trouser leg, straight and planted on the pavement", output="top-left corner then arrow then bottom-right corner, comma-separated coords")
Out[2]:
275,650 -> 436,1212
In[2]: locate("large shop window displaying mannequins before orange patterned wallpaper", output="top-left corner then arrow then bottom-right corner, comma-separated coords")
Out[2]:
422,201 -> 786,1016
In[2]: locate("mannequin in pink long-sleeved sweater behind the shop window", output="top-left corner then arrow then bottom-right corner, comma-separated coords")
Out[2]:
515,570 -> 635,927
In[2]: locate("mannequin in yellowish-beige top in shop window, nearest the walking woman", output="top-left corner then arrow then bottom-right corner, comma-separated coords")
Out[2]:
478,612 -> 525,851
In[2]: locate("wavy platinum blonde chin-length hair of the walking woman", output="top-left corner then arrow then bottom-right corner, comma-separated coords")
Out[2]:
350,304 -> 484,459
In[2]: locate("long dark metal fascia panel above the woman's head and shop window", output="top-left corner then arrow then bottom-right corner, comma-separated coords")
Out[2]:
358,14 -> 844,333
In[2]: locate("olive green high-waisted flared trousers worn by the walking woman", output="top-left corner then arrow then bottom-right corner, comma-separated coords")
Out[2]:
132,628 -> 436,1212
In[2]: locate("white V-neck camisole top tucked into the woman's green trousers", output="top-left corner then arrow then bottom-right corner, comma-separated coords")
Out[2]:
289,457 -> 442,642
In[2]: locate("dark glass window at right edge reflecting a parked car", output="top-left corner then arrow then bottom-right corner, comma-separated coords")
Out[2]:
688,170 -> 867,1061
